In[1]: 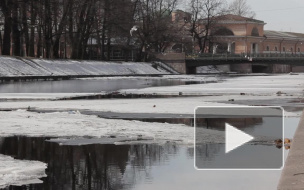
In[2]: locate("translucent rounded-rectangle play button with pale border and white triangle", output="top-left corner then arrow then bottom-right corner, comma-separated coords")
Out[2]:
194,106 -> 284,170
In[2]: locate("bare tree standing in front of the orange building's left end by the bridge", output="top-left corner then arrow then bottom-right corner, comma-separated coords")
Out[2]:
189,0 -> 225,53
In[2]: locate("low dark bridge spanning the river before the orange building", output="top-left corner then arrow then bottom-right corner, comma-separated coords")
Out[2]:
154,53 -> 304,74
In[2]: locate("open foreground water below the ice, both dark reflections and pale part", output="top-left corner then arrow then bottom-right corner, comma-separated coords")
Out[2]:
0,118 -> 299,190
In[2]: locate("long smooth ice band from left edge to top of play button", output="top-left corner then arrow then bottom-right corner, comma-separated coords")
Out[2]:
0,94 -> 300,117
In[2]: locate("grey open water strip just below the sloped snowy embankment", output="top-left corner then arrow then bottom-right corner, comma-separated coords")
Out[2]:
0,77 -> 207,93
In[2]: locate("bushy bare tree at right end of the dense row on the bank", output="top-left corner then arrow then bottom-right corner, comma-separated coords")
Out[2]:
134,0 -> 177,61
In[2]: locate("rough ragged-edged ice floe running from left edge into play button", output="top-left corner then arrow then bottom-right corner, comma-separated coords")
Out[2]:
0,110 -> 223,144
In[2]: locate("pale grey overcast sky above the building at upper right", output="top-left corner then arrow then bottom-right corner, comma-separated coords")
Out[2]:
178,0 -> 304,33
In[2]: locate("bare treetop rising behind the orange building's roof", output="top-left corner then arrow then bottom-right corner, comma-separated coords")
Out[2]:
228,0 -> 256,18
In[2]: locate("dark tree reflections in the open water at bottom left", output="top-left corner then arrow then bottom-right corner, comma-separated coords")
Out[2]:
0,137 -> 178,190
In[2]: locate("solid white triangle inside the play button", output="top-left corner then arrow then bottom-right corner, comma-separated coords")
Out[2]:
225,123 -> 254,153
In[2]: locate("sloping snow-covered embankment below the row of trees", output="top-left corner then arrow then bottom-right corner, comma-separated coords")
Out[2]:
0,56 -> 170,77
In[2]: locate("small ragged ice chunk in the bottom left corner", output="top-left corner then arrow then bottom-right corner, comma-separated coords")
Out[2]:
0,154 -> 47,188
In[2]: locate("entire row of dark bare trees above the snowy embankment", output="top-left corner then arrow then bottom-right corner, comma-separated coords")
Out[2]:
0,0 -> 255,60
